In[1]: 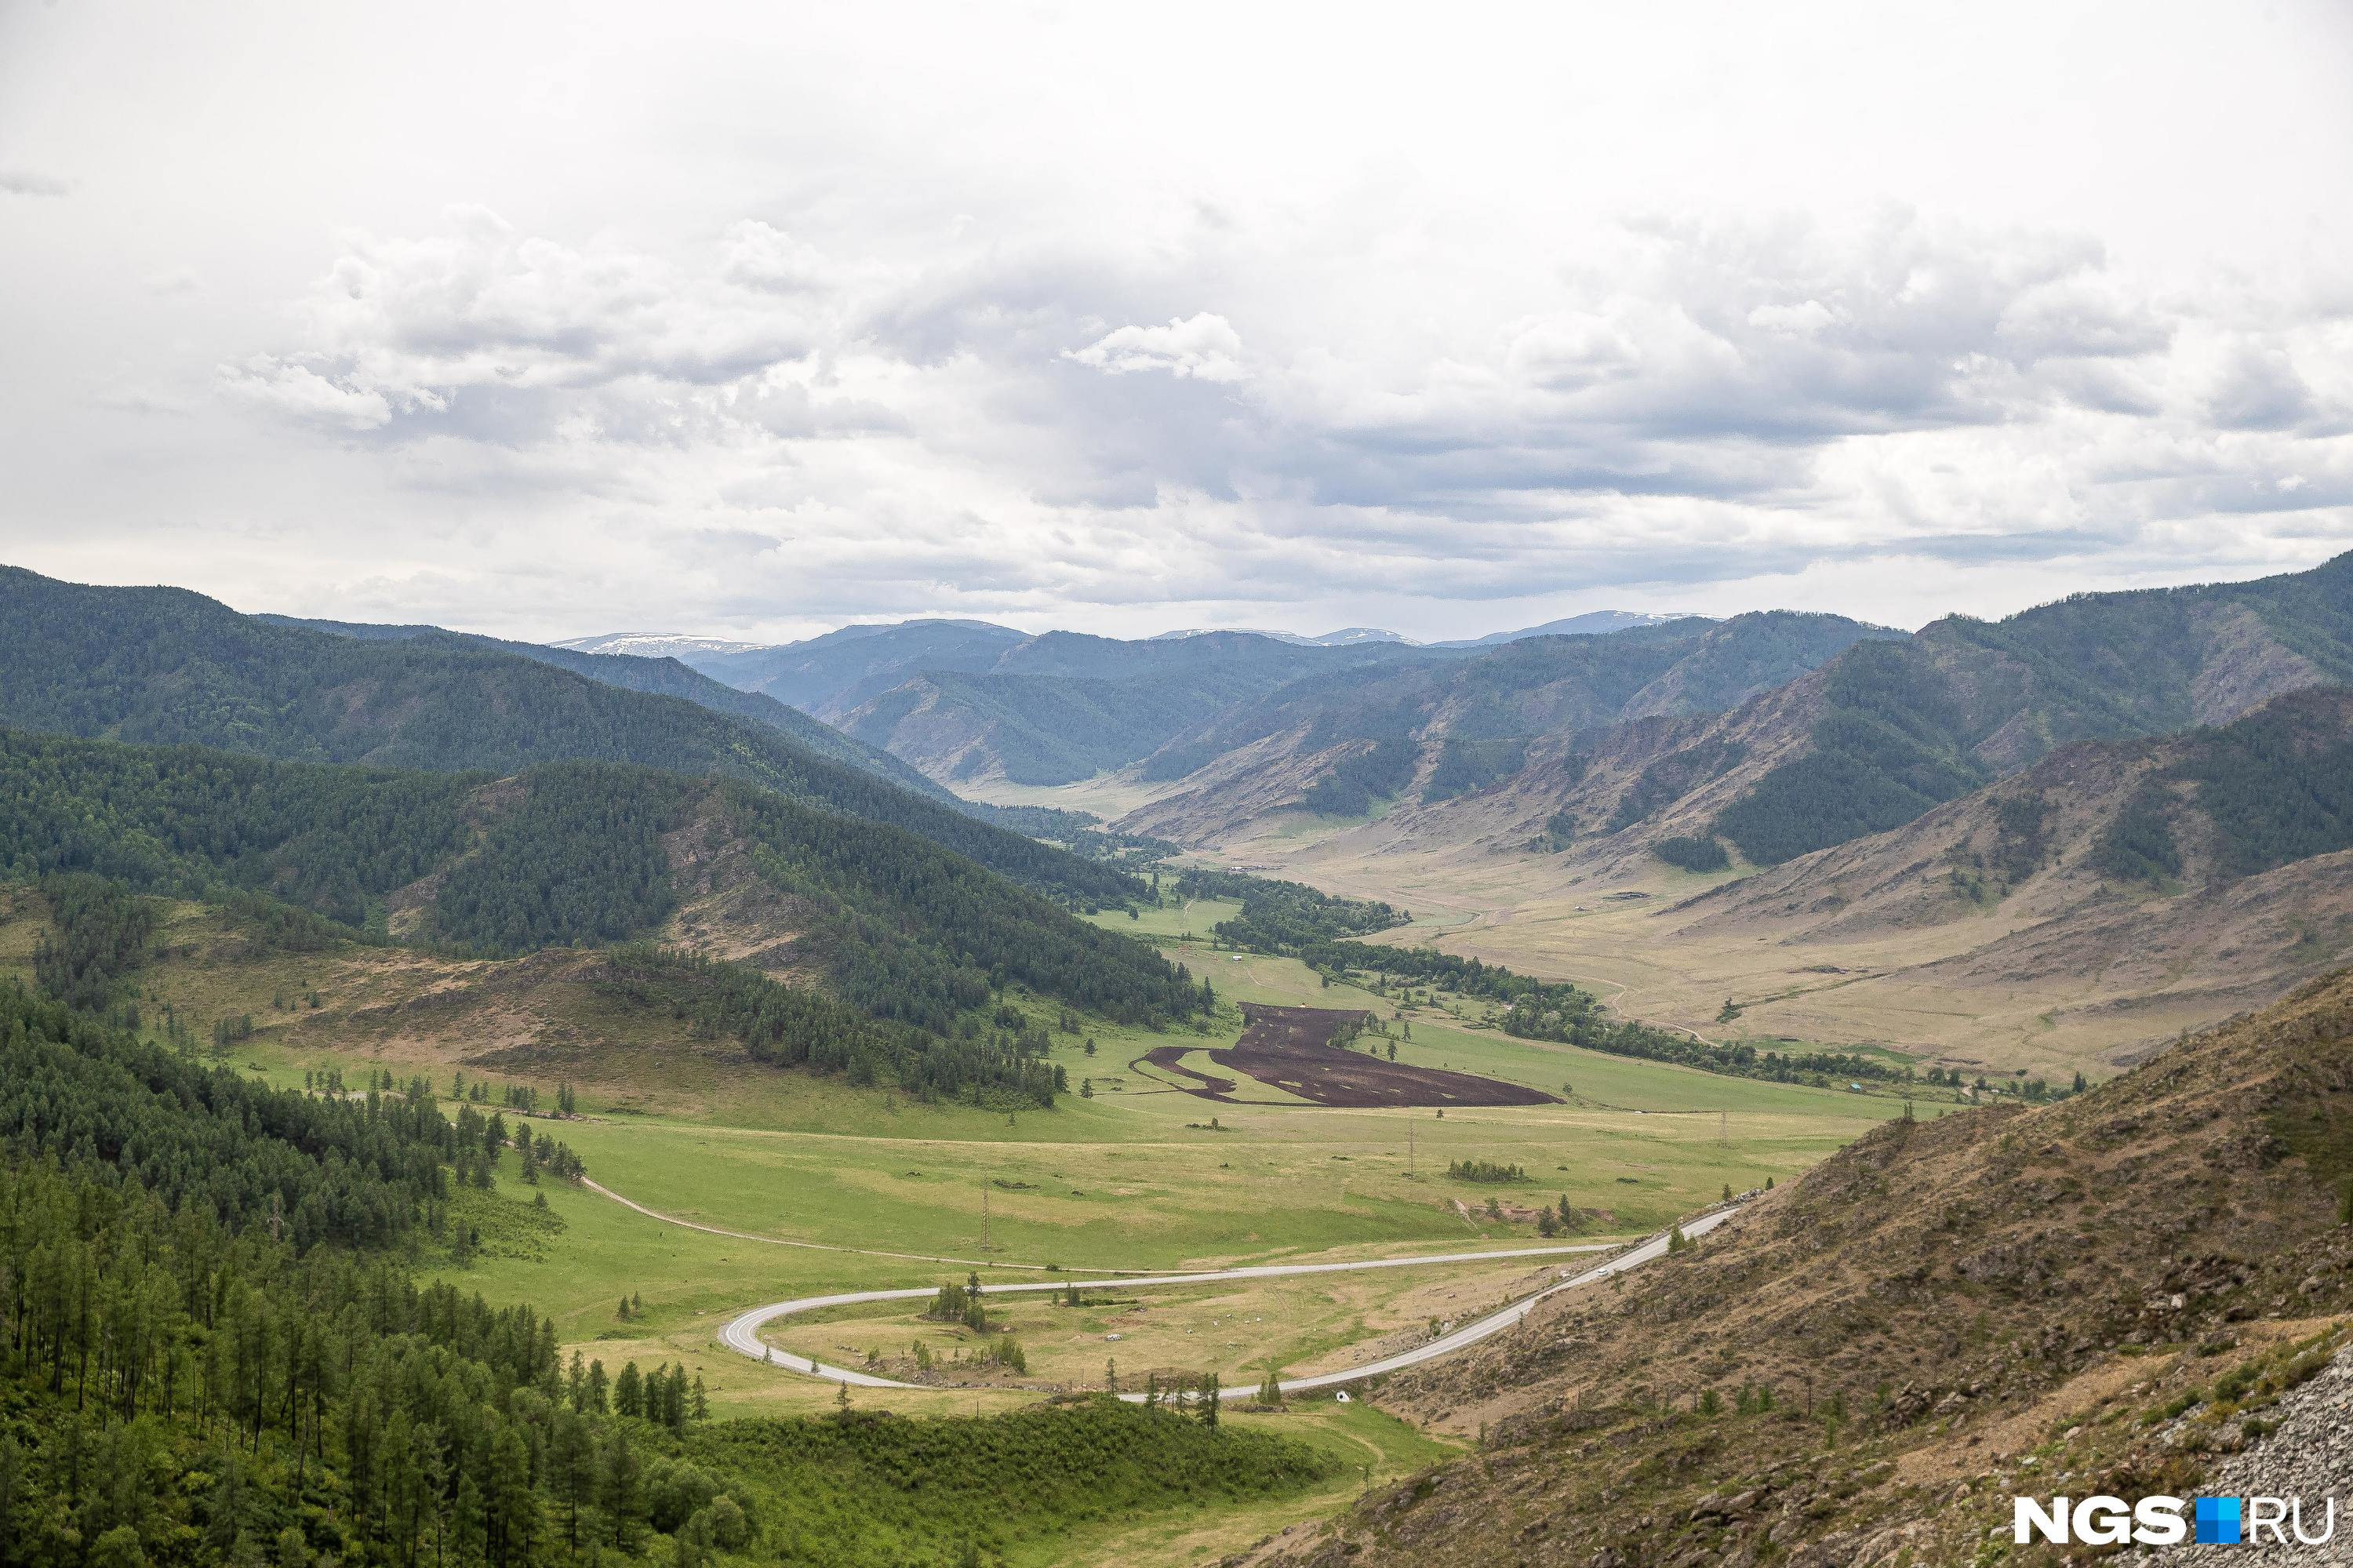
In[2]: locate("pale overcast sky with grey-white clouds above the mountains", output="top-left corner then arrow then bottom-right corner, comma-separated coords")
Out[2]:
0,0 -> 2353,640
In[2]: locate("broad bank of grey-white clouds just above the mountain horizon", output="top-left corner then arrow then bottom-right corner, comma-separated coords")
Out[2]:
170,209 -> 2353,624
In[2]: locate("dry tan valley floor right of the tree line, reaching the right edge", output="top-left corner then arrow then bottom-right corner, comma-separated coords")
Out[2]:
984,781 -> 2325,1081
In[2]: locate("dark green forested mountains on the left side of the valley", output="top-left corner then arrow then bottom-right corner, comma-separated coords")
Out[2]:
0,569 -> 1209,1104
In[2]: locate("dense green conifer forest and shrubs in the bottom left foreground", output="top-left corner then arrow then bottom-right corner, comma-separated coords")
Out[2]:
0,941 -> 1327,1568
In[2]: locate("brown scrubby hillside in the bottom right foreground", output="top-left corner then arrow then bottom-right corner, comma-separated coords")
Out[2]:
1268,975 -> 2353,1568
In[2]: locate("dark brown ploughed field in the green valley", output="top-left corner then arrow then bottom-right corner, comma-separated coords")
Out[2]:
1139,1003 -> 1558,1107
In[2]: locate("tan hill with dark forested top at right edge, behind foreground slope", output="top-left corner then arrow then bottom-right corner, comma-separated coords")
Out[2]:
1657,687 -> 2353,1060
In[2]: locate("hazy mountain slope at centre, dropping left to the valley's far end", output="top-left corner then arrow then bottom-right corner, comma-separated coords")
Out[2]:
1122,612 -> 1901,841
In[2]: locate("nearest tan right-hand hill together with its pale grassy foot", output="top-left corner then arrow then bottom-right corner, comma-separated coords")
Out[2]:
1129,687 -> 2353,1079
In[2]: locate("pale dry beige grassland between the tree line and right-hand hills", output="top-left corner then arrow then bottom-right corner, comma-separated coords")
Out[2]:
1144,799 -> 2240,1081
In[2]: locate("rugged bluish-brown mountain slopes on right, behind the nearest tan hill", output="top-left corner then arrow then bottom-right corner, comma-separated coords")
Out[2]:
1101,555 -> 2353,880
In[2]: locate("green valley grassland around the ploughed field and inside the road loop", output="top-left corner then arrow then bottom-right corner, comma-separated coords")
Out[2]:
0,893 -> 1897,1563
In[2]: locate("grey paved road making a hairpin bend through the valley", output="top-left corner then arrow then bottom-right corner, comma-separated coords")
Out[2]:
720,1208 -> 1737,1403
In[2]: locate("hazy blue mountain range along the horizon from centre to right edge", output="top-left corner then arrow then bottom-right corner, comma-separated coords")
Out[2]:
229,555 -> 2353,993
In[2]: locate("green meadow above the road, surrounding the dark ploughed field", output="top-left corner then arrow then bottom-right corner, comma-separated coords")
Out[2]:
0,880 -> 1894,1314
